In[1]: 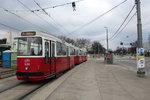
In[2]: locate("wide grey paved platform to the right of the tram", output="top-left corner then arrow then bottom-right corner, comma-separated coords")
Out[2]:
31,59 -> 150,100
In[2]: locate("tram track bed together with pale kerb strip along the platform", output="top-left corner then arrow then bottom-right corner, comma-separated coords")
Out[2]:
0,63 -> 84,100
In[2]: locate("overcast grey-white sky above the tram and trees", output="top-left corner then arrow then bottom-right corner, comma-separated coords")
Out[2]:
0,0 -> 150,49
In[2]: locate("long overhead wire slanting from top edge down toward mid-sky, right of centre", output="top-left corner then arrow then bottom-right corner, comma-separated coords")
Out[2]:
67,0 -> 127,36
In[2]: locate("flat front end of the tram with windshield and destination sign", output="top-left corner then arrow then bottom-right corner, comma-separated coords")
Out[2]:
16,32 -> 44,81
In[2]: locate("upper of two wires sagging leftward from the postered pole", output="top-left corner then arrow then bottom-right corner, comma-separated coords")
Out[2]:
109,5 -> 135,40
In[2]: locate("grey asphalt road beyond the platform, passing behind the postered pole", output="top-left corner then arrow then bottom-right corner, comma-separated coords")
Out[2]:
114,56 -> 150,74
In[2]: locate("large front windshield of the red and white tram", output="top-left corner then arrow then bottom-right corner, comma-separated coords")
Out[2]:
18,37 -> 42,56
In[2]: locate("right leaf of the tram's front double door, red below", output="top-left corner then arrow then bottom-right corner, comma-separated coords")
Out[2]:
50,41 -> 55,74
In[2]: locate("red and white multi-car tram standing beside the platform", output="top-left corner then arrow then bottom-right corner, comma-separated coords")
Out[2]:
15,31 -> 87,81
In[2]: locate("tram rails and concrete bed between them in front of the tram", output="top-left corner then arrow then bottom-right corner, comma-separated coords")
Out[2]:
0,80 -> 53,100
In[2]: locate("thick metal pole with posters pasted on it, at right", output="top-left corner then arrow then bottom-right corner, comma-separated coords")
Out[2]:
135,0 -> 145,76
